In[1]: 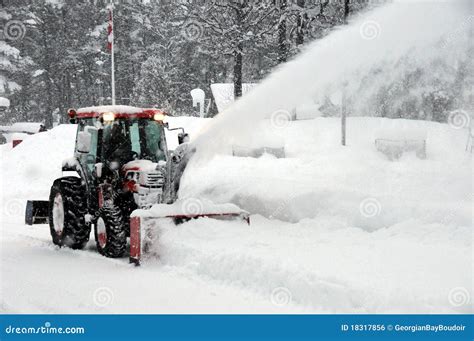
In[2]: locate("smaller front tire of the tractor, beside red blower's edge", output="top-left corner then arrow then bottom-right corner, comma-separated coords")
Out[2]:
94,206 -> 128,258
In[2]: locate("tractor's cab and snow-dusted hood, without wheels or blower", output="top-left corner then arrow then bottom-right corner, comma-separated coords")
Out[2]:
68,106 -> 185,211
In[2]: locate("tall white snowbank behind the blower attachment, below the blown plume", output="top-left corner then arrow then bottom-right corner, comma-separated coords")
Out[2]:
180,117 -> 472,230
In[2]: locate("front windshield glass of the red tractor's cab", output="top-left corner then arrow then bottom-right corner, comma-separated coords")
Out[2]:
103,119 -> 166,164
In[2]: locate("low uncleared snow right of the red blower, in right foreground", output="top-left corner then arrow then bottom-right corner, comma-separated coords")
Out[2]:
156,216 -> 472,313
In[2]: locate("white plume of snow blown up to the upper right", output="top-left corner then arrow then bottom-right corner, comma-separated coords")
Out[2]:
195,0 -> 474,156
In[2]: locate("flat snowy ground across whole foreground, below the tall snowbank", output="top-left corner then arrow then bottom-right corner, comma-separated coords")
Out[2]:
2,212 -> 471,313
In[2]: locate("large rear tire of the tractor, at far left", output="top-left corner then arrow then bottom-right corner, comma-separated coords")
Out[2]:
48,177 -> 90,249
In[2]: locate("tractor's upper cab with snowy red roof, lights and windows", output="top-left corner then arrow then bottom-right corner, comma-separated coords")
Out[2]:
68,106 -> 168,168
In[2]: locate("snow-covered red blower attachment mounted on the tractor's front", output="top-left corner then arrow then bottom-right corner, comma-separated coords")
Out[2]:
130,199 -> 250,265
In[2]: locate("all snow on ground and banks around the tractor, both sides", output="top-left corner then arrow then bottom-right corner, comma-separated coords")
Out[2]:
0,117 -> 473,313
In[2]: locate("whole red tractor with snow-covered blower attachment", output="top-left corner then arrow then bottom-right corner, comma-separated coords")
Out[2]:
25,105 -> 249,263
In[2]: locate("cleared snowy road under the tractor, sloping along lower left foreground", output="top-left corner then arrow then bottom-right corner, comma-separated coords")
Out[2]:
1,216 -> 302,313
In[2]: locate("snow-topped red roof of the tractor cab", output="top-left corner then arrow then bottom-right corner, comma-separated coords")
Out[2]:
70,105 -> 165,119
